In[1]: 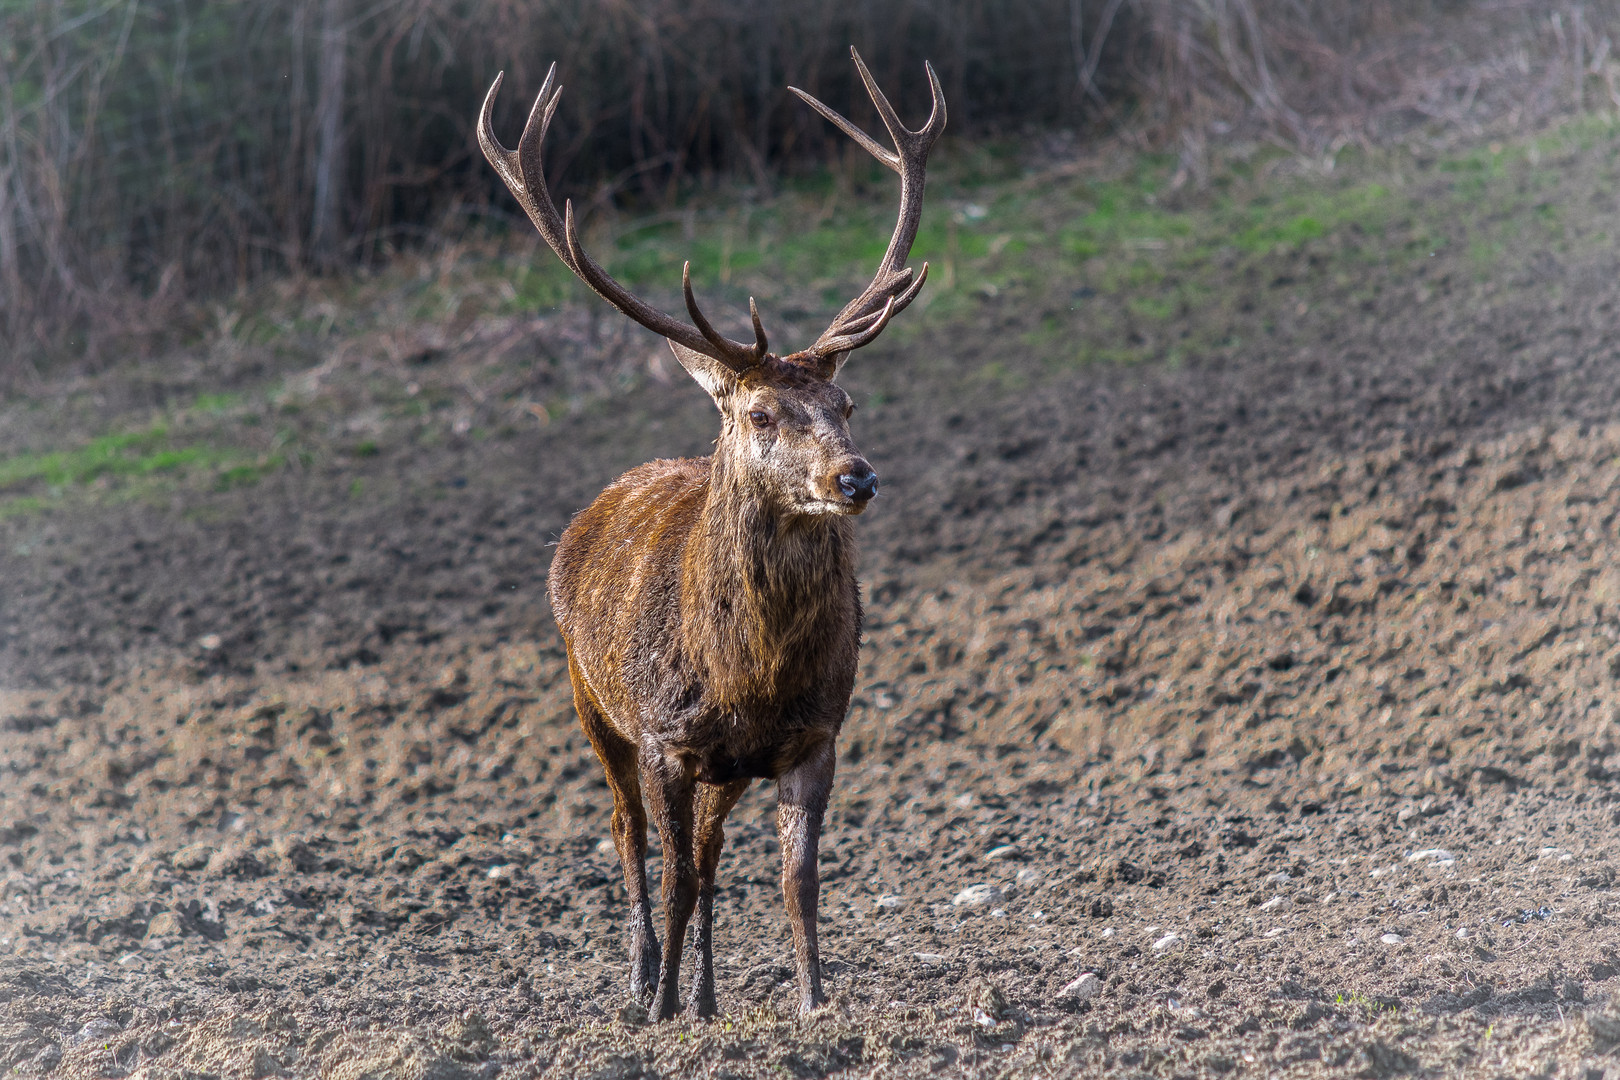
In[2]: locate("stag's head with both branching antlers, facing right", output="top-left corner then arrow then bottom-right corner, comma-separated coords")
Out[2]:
478,49 -> 944,515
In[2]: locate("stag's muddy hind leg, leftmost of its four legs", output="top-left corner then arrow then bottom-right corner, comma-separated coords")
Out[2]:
569,664 -> 658,1002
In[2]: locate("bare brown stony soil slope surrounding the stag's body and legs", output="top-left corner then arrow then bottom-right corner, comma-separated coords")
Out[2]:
0,145 -> 1620,1080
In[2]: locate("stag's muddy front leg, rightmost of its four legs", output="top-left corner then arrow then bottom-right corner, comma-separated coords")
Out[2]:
776,738 -> 836,1014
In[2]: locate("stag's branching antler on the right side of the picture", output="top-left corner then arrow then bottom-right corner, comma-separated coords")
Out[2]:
787,47 -> 944,369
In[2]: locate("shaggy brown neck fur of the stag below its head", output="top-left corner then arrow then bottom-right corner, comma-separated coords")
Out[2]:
682,453 -> 859,699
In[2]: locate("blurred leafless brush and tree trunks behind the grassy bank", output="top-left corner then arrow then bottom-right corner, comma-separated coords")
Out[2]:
0,0 -> 1614,384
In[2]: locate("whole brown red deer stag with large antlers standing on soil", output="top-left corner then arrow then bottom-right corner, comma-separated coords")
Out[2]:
478,50 -> 944,1020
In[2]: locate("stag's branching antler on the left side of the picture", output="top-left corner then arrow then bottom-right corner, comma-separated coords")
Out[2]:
478,63 -> 767,374
